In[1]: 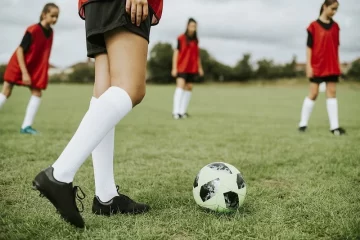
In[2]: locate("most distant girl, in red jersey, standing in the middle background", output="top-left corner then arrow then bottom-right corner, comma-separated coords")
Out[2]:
171,18 -> 204,119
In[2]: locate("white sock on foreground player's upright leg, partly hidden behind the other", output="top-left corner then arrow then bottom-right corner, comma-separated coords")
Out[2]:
90,97 -> 119,202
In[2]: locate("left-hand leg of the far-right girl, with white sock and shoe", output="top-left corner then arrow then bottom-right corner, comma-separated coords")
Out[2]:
299,82 -> 319,131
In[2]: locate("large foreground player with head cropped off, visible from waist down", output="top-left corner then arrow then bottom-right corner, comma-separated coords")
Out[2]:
33,0 -> 163,228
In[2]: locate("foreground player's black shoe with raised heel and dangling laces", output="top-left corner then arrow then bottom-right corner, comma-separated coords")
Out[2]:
33,167 -> 85,228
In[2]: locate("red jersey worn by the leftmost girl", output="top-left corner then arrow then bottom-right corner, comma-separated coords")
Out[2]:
4,24 -> 53,89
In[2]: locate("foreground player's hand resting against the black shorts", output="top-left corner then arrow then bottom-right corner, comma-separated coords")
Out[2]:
126,0 -> 149,26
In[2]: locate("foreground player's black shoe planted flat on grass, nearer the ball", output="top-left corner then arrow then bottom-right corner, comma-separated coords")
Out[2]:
92,187 -> 150,216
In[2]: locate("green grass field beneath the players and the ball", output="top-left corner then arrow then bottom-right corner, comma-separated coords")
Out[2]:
0,84 -> 360,240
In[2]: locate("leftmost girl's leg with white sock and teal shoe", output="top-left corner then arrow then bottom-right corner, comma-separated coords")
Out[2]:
21,88 -> 42,134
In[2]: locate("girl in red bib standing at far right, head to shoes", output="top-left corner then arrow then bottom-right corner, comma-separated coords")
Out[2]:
299,0 -> 345,135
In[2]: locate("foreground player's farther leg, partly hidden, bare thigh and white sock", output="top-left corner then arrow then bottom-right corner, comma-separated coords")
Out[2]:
90,54 -> 118,202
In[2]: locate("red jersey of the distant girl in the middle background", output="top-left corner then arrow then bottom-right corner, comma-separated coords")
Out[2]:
177,34 -> 200,74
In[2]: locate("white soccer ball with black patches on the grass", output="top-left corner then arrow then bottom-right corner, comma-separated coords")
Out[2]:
193,162 -> 246,212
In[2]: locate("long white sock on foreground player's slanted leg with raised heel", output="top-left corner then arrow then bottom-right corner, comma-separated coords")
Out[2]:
52,87 -> 132,183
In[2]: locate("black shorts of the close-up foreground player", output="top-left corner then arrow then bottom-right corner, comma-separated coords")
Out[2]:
85,0 -> 153,58
